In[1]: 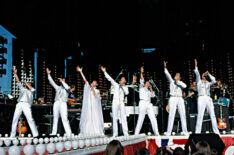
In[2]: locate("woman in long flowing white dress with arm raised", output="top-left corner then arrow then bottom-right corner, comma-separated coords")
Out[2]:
76,66 -> 104,136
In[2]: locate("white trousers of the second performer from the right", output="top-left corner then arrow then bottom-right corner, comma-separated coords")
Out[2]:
167,97 -> 188,135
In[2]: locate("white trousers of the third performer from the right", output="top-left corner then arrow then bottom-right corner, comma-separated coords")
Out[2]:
135,100 -> 159,136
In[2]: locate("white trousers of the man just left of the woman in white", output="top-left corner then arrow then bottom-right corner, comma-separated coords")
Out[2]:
52,101 -> 71,136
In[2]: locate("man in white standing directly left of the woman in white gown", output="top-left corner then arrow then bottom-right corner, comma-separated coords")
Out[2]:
46,68 -> 72,137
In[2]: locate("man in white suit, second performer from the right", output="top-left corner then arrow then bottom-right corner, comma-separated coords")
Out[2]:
164,61 -> 188,136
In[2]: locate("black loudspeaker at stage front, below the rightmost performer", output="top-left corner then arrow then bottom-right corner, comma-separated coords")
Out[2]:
185,133 -> 225,154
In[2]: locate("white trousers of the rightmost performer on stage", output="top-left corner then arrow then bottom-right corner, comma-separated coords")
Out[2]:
196,96 -> 219,134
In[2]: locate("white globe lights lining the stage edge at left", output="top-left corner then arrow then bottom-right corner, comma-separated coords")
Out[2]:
0,134 -> 146,155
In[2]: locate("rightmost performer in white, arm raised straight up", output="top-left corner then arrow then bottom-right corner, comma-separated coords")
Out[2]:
194,59 -> 219,134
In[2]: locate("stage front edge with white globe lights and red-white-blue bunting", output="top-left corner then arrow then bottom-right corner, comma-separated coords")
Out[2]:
0,134 -> 234,155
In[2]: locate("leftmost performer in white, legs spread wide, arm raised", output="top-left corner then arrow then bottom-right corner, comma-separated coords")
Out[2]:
11,67 -> 38,137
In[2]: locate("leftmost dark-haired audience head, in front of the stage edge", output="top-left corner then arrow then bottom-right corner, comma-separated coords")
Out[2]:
104,140 -> 124,155
